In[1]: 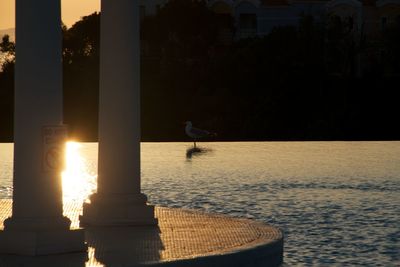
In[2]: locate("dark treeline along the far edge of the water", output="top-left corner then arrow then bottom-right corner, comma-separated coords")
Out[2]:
0,0 -> 400,141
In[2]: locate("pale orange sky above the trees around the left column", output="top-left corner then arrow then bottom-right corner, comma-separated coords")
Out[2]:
0,0 -> 100,30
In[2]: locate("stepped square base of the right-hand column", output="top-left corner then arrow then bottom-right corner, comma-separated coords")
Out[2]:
79,194 -> 158,227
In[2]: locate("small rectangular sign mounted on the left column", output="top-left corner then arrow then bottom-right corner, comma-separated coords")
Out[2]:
42,125 -> 68,172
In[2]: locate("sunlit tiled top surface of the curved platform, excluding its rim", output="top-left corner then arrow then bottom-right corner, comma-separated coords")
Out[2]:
0,200 -> 283,267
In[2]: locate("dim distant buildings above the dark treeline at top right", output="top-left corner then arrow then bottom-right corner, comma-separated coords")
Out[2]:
140,0 -> 400,40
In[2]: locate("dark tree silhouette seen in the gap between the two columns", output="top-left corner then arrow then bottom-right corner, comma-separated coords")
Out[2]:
63,13 -> 100,140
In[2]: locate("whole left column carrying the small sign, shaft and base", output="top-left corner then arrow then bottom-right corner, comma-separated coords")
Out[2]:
0,0 -> 86,255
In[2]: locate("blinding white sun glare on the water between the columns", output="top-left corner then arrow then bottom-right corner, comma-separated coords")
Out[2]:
62,141 -> 96,202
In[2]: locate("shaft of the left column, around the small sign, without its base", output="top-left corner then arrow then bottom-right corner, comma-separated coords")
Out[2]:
13,0 -> 62,220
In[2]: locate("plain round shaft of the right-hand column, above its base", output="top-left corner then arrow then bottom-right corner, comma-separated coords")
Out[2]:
98,0 -> 140,194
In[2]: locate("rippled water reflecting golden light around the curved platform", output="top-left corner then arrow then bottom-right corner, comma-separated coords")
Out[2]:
0,142 -> 400,266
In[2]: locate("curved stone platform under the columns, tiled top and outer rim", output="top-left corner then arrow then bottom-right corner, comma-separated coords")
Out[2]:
0,200 -> 283,267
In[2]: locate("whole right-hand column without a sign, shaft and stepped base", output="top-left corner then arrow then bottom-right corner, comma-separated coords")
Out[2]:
80,0 -> 157,225
